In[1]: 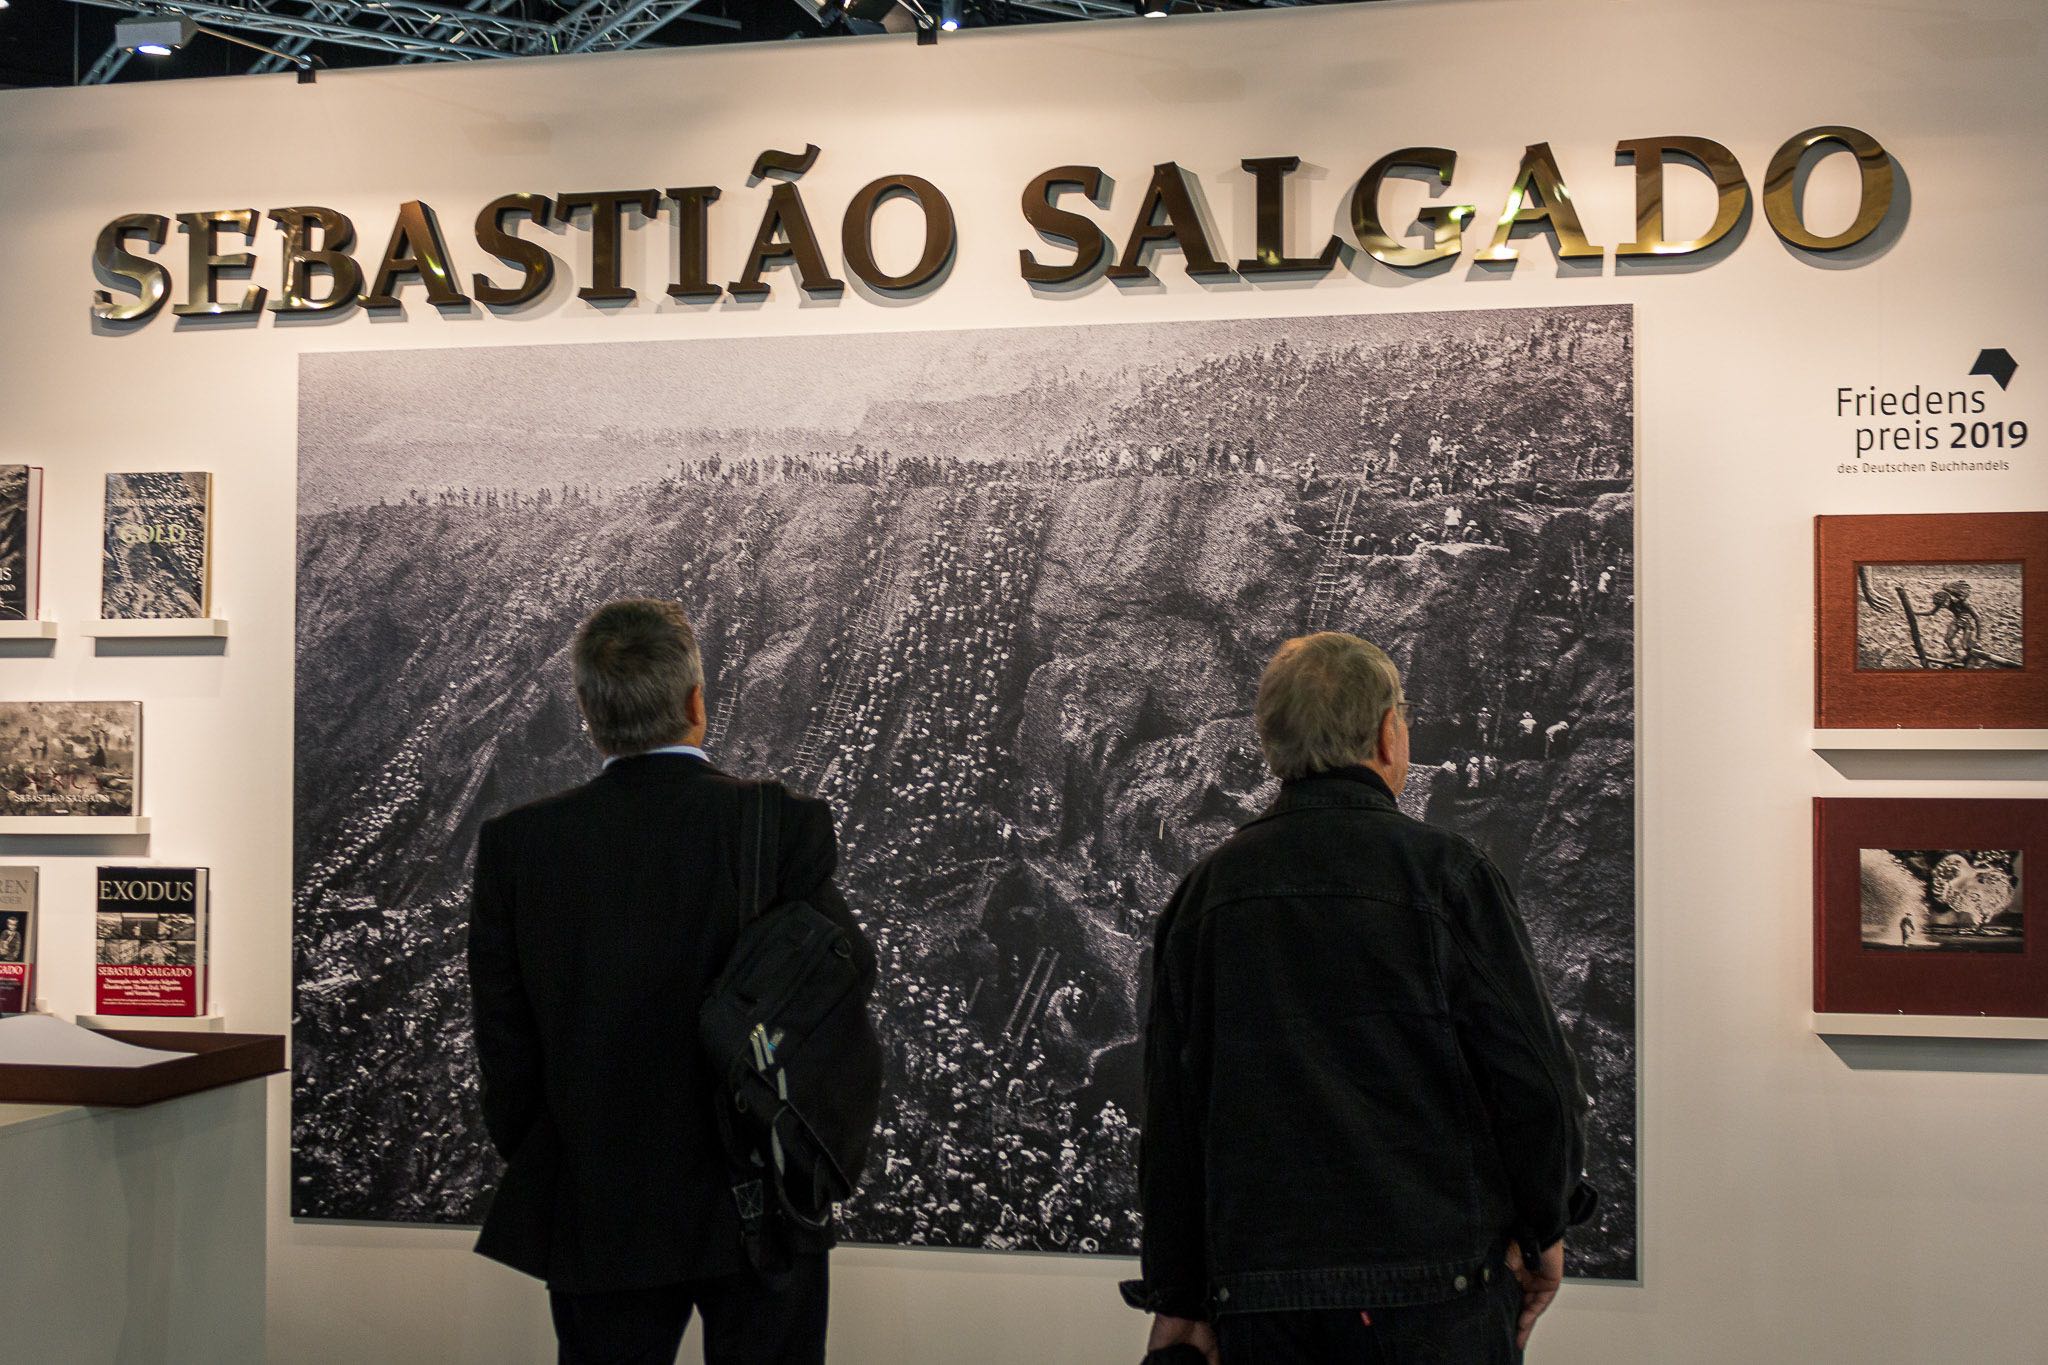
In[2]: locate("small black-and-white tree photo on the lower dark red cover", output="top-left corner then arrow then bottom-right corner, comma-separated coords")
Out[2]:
1858,849 -> 2025,954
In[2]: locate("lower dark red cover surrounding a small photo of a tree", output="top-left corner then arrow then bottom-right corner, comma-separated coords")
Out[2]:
1812,796 -> 2048,1019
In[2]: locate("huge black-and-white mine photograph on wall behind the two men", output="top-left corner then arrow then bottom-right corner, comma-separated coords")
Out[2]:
293,307 -> 1636,1279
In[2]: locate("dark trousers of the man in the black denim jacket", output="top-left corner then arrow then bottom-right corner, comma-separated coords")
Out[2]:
1217,1265 -> 1522,1365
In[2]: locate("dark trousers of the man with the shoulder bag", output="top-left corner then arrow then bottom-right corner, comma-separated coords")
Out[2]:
549,1254 -> 829,1365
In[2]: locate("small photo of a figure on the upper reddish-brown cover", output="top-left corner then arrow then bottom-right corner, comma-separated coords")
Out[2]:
1855,563 -> 2025,669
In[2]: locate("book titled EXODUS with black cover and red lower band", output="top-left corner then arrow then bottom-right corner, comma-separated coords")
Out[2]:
92,868 -> 209,1017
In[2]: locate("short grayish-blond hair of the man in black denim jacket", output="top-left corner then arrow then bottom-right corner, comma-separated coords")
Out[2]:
1253,630 -> 1401,782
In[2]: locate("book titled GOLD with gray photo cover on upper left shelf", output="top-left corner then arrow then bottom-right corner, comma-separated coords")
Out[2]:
100,475 -> 213,620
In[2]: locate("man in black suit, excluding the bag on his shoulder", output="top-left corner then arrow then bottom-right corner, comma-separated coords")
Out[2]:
469,600 -> 874,1365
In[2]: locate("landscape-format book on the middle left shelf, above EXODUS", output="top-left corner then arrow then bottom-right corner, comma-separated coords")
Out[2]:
0,702 -> 141,819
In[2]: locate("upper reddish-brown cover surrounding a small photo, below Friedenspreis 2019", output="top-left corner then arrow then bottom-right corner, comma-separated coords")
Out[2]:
1812,512 -> 2048,731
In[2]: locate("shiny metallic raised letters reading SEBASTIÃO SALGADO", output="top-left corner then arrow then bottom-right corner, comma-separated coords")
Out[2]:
92,125 -> 1896,323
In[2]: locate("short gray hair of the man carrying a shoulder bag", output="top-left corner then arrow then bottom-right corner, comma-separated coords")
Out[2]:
571,598 -> 705,755
